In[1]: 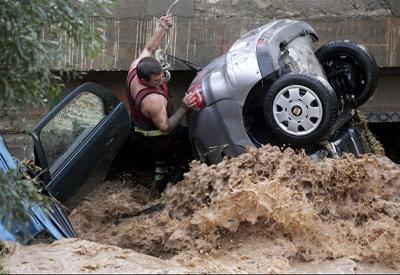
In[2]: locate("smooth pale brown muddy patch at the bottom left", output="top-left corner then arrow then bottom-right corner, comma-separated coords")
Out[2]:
0,239 -> 187,274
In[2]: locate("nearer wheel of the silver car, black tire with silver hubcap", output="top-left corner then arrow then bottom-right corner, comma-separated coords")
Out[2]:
264,74 -> 338,145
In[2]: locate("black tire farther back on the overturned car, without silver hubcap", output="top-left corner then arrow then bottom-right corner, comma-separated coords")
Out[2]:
315,40 -> 378,107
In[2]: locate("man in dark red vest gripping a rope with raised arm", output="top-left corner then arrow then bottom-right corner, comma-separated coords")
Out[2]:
127,15 -> 196,194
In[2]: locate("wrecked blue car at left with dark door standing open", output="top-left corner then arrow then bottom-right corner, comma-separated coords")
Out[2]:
0,83 -> 130,244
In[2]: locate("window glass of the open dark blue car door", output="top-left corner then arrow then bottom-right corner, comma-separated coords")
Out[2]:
40,92 -> 106,175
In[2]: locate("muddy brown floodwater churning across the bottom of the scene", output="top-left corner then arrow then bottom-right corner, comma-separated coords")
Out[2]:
3,145 -> 400,273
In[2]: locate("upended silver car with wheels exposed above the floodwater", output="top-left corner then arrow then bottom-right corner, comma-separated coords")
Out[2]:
187,20 -> 378,163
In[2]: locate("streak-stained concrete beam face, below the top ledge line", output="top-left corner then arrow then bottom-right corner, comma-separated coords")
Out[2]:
55,16 -> 400,71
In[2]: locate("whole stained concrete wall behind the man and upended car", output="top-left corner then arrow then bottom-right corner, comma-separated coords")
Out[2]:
55,0 -> 400,71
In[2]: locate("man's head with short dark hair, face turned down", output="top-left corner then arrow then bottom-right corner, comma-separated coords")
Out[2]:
136,57 -> 164,87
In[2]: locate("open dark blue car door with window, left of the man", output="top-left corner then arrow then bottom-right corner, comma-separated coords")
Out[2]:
32,83 -> 131,207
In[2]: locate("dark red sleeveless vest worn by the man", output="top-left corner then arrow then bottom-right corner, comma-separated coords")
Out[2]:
126,68 -> 174,134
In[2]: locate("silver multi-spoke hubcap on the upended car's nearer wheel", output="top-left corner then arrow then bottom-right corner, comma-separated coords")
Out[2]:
273,85 -> 323,136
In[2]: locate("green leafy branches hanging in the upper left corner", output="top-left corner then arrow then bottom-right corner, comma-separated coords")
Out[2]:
0,0 -> 112,117
